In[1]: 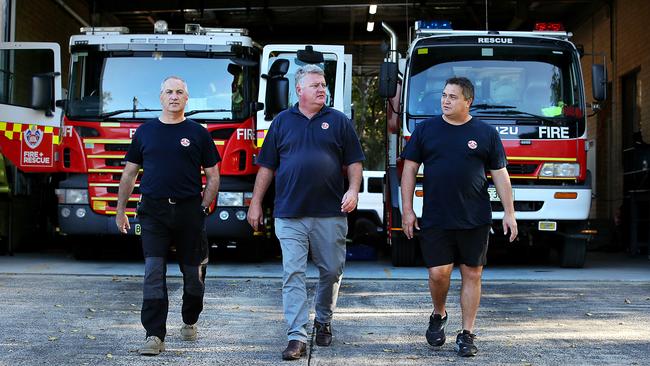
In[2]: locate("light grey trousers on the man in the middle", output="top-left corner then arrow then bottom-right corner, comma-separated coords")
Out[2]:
275,216 -> 348,342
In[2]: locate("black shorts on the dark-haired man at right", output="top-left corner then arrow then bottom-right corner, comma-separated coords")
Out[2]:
418,225 -> 490,268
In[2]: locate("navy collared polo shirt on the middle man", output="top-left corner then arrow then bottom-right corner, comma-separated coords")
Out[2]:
256,105 -> 365,218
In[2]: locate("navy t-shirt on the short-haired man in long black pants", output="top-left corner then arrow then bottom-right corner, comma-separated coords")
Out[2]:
125,118 -> 221,199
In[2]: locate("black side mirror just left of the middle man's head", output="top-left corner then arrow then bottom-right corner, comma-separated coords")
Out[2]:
263,58 -> 289,121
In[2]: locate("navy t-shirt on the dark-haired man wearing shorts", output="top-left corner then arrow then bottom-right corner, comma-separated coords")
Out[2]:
402,116 -> 507,229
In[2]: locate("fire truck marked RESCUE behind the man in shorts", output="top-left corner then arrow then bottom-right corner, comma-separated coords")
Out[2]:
380,22 -> 606,267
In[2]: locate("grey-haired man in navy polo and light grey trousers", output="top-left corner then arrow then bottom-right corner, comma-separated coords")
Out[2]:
248,65 -> 365,360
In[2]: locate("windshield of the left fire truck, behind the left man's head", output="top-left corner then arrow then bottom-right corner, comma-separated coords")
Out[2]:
66,51 -> 257,122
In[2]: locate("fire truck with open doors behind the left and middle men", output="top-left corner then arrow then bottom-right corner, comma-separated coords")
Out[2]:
0,21 -> 351,257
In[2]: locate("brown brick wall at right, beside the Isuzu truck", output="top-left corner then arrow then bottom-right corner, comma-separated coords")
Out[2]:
572,0 -> 650,223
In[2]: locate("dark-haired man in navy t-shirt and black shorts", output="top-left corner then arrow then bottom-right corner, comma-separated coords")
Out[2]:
401,77 -> 517,356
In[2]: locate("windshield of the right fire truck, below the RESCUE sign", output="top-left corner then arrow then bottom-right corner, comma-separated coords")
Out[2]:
406,45 -> 584,129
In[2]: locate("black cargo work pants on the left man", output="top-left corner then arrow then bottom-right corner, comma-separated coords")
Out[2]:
138,196 -> 208,340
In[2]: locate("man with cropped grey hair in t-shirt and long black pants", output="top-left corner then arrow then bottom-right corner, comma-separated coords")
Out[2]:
115,76 -> 221,355
